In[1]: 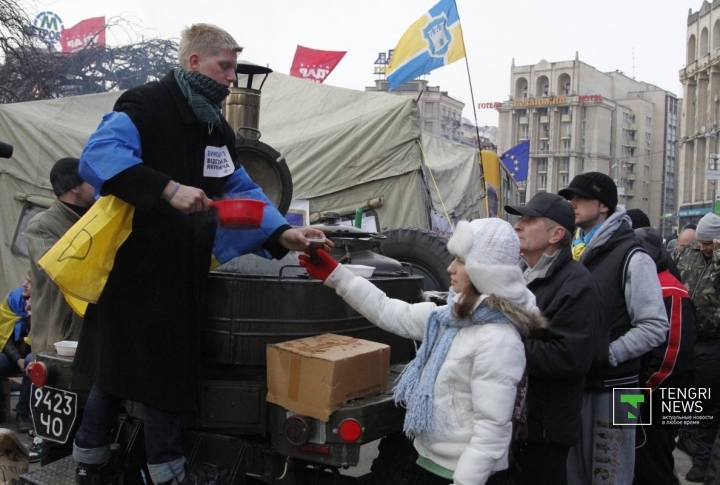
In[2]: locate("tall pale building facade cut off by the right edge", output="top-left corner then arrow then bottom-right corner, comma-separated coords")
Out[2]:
677,0 -> 720,228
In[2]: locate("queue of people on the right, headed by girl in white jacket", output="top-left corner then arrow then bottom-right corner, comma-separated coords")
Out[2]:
300,172 -> 708,485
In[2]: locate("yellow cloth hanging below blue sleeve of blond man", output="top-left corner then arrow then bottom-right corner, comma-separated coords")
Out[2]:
38,195 -> 135,316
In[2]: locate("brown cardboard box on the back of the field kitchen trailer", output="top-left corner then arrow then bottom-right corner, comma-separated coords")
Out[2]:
267,333 -> 390,421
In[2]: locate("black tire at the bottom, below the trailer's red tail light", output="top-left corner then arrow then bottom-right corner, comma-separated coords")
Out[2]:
367,433 -> 418,485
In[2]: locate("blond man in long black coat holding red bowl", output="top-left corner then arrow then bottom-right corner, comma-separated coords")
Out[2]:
73,24 -> 323,485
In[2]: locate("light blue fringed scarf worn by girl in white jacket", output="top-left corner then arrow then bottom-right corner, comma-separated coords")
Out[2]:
394,291 -> 512,438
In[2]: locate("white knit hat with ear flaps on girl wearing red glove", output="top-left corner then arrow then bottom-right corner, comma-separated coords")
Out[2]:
448,217 -> 535,307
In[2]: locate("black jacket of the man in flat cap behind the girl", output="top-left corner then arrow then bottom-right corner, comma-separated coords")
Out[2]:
521,247 -> 602,446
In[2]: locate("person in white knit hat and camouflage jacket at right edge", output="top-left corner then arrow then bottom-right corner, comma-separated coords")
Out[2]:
676,213 -> 720,482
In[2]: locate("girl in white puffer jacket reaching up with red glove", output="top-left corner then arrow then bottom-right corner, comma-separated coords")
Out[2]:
300,218 -> 544,485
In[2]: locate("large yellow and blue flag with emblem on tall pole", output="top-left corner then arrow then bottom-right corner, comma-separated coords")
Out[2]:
385,0 -> 465,91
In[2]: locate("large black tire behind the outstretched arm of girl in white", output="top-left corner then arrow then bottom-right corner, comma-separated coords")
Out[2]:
380,227 -> 453,291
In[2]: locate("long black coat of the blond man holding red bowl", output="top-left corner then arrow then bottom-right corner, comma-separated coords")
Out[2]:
75,72 -> 287,412
